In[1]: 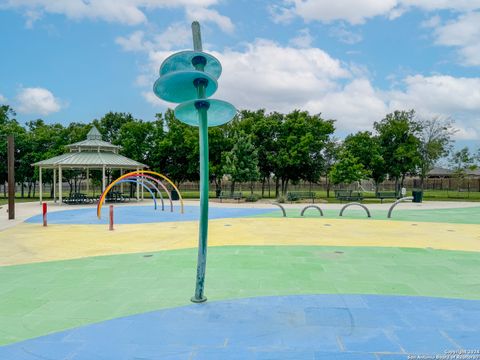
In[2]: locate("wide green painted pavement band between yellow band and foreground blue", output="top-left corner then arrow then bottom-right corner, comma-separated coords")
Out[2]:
0,246 -> 480,345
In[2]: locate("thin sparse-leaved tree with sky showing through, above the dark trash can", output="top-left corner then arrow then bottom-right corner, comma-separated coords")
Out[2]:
419,117 -> 456,189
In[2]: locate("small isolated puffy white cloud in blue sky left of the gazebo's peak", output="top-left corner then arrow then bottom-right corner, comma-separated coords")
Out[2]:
16,87 -> 62,116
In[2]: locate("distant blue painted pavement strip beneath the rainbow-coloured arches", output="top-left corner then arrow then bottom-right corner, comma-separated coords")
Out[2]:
25,206 -> 275,224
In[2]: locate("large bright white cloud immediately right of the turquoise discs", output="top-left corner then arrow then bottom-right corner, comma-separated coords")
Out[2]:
214,40 -> 350,111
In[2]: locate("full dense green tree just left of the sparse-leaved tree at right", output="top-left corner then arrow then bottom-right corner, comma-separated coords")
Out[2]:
374,110 -> 422,191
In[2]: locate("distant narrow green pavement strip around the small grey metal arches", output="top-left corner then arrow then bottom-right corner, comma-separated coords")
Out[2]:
252,204 -> 480,224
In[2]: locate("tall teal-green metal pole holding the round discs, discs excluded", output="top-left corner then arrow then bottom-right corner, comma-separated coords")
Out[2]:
191,21 -> 209,303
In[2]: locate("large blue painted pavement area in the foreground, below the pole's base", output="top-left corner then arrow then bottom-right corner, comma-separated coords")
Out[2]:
0,295 -> 480,360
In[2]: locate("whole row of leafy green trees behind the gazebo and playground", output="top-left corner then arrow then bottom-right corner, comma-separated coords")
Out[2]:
0,105 -> 480,197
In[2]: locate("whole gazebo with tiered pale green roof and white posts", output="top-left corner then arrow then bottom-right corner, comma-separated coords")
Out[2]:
32,126 -> 148,204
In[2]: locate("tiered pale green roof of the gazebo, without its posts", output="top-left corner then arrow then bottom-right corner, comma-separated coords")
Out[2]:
32,126 -> 148,169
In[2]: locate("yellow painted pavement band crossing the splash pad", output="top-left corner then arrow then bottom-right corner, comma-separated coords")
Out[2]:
0,218 -> 480,266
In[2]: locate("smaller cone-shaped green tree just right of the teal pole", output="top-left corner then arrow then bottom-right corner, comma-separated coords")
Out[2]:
224,131 -> 260,195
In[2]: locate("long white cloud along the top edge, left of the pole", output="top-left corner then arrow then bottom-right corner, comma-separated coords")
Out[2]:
0,0 -> 228,27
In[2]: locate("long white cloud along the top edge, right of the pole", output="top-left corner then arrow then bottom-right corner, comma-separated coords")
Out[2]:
272,0 -> 480,24
